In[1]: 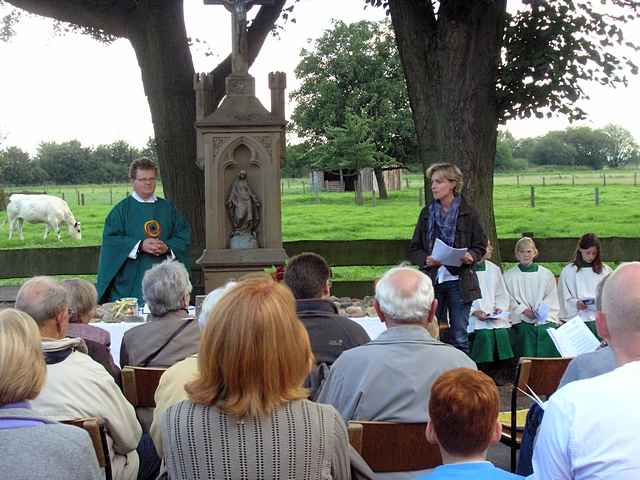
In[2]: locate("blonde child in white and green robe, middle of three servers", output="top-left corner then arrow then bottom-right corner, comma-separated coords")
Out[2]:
504,237 -> 560,357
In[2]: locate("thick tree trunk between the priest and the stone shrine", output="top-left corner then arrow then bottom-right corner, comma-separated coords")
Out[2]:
128,2 -> 205,245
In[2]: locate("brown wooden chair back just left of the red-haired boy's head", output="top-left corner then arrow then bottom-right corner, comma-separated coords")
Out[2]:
348,421 -> 442,473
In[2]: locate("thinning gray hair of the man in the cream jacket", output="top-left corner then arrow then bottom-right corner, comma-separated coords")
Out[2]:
15,277 -> 69,327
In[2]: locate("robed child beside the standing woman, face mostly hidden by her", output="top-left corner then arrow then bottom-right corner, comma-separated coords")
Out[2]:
468,242 -> 514,363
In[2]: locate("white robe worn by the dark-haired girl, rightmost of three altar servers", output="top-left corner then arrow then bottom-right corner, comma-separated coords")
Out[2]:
558,263 -> 611,322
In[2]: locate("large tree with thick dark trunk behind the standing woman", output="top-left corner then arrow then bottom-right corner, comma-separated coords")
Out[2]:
365,0 -> 640,256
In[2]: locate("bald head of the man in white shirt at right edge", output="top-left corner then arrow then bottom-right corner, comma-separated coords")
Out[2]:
602,262 -> 640,342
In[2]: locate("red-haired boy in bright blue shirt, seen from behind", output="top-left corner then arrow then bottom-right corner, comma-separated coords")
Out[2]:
422,368 -> 524,480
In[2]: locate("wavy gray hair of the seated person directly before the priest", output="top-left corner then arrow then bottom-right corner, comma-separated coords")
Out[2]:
142,260 -> 192,317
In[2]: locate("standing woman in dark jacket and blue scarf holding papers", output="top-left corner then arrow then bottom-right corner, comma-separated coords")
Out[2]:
409,163 -> 486,353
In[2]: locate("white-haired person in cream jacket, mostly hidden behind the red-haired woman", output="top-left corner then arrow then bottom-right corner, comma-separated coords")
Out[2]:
149,282 -> 236,458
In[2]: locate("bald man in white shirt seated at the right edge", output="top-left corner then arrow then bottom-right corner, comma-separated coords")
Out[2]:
531,262 -> 640,480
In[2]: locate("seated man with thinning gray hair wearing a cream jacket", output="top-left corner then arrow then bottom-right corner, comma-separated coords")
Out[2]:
16,277 -> 142,480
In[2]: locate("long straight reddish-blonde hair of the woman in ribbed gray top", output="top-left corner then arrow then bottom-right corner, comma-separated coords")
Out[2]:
185,276 -> 313,417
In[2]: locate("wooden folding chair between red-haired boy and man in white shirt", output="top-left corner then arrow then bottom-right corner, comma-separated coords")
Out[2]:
500,357 -> 571,472
